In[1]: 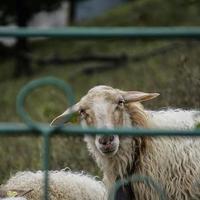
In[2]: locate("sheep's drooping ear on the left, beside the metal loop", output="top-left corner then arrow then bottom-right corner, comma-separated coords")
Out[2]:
50,103 -> 80,126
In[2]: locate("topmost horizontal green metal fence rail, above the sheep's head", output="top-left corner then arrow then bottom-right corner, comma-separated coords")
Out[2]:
0,27 -> 200,39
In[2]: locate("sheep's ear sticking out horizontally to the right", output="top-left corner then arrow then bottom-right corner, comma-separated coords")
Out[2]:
122,91 -> 160,103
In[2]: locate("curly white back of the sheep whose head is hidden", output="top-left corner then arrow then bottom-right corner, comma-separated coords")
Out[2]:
0,170 -> 107,200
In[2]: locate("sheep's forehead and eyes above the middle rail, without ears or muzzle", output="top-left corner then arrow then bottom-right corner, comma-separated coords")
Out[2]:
79,87 -> 124,128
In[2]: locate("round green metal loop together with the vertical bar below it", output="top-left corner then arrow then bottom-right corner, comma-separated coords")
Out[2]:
16,77 -> 75,200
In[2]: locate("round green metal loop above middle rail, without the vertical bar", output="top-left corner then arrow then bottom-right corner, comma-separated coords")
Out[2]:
16,77 -> 75,130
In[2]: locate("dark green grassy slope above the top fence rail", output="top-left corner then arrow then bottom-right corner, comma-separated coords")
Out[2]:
86,0 -> 200,26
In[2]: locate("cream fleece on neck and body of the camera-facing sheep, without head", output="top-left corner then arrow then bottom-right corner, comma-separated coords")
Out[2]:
85,109 -> 200,200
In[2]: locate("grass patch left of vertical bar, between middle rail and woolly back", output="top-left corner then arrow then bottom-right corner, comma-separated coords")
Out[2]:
0,136 -> 42,183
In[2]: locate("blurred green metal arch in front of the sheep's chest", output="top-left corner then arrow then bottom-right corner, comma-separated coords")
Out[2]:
108,174 -> 167,200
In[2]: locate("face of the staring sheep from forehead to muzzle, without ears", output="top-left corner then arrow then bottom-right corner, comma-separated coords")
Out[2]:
79,88 -> 122,155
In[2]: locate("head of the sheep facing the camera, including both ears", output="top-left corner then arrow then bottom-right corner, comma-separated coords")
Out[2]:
51,86 -> 159,155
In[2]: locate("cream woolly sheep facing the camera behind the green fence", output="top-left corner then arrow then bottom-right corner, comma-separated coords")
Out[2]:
51,86 -> 200,200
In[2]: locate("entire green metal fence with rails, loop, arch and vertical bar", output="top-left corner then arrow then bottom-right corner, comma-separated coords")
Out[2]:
0,27 -> 200,200
